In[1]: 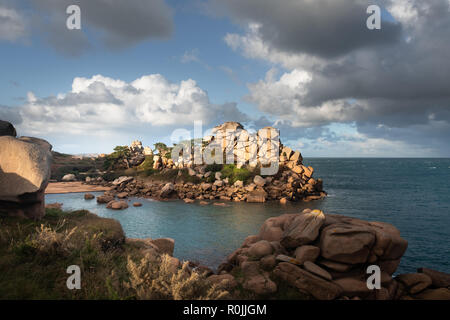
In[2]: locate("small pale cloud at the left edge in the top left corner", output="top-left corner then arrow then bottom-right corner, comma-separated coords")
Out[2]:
0,6 -> 26,41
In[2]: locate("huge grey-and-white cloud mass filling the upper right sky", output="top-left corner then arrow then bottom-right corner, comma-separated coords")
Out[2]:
219,0 -> 450,155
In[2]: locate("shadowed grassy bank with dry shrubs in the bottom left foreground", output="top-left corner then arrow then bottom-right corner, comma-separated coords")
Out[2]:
0,209 -> 228,299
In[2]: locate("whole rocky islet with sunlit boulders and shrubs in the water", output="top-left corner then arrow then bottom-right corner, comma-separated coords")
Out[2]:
81,122 -> 326,208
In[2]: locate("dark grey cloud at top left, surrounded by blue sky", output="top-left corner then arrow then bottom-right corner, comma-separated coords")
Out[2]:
25,0 -> 173,56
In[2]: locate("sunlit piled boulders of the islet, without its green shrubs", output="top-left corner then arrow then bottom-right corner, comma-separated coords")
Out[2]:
89,122 -> 326,203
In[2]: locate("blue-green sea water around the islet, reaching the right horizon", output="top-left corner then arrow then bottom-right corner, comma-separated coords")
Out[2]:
46,158 -> 450,272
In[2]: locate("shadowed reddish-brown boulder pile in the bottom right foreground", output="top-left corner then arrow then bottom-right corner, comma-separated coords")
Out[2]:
212,209 -> 450,300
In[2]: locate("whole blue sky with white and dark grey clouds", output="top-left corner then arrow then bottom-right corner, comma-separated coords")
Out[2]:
0,0 -> 450,157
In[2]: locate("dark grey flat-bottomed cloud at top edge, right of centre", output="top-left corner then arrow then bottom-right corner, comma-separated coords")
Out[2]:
213,0 -> 402,58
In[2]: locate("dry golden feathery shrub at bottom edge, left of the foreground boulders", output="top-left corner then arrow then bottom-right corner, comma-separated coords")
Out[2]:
124,255 -> 229,300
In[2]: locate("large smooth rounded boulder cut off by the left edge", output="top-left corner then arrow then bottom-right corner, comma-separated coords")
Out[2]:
0,136 -> 52,219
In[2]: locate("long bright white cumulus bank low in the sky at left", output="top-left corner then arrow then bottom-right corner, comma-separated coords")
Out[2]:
0,74 -> 246,136
